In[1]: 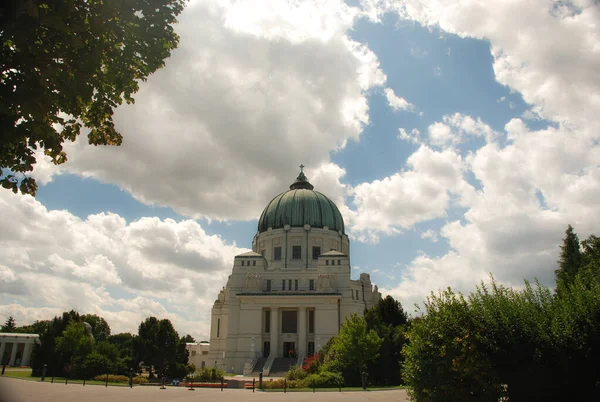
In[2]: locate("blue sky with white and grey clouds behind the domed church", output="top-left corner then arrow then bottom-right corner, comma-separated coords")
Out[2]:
0,0 -> 600,339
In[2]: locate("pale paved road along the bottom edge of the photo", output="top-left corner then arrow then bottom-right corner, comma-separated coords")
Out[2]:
0,378 -> 409,402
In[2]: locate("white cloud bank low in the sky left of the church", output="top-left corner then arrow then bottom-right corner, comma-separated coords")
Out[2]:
0,191 -> 246,339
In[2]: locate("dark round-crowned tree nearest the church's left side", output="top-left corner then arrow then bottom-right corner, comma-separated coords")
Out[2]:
136,317 -> 188,377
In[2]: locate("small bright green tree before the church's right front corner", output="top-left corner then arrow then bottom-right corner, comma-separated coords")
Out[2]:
329,314 -> 383,386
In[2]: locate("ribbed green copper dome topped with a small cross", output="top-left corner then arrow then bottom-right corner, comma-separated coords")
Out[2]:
258,165 -> 344,233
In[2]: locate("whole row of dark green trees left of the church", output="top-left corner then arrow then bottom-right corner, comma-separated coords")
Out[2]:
2,310 -> 194,379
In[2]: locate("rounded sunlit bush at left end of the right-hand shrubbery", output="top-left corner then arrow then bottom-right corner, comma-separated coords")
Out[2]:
403,289 -> 502,402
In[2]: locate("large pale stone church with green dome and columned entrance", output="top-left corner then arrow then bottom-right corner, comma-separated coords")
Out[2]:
208,166 -> 381,375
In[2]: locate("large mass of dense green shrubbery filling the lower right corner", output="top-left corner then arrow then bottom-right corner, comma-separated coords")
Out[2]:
404,274 -> 600,401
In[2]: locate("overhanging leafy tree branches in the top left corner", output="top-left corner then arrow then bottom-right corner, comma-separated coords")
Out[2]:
0,0 -> 185,195
